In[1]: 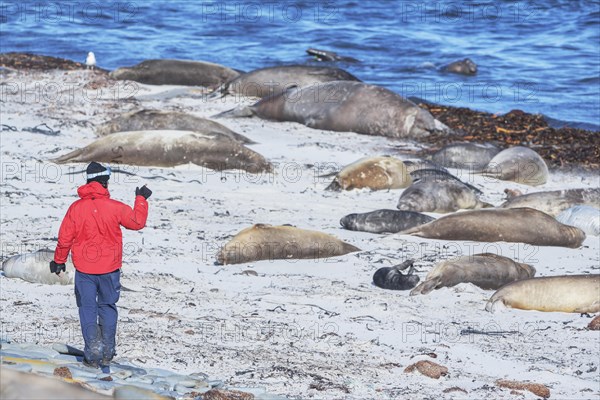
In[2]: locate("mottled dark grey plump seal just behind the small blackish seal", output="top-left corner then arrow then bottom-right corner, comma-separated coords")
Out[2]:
396,176 -> 492,213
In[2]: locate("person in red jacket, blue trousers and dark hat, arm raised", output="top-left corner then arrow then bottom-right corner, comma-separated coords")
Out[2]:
50,162 -> 152,370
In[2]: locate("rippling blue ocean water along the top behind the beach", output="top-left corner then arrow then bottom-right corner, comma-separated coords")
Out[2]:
0,0 -> 600,130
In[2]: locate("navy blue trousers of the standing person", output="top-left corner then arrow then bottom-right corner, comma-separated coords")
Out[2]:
75,269 -> 121,365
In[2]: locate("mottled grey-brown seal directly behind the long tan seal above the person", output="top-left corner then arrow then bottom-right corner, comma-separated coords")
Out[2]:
96,110 -> 255,144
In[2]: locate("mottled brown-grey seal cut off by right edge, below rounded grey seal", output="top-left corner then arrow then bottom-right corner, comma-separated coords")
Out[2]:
500,188 -> 600,217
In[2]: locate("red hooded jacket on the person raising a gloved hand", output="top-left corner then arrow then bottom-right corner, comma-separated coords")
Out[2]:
54,182 -> 148,274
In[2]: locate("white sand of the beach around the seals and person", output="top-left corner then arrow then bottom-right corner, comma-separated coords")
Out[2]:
0,71 -> 600,399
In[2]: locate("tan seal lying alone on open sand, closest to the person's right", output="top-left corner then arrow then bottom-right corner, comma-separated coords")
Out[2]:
216,224 -> 360,265
